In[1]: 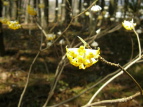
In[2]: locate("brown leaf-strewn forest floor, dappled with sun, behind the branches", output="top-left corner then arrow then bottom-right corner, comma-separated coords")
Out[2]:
0,24 -> 143,107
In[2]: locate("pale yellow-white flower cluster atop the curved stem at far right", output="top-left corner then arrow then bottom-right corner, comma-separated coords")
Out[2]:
122,19 -> 136,30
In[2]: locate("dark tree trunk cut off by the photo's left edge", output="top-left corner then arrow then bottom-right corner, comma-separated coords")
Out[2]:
0,0 -> 5,56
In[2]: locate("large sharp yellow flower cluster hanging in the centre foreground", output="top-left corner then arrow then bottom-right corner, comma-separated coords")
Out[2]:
66,46 -> 100,69
